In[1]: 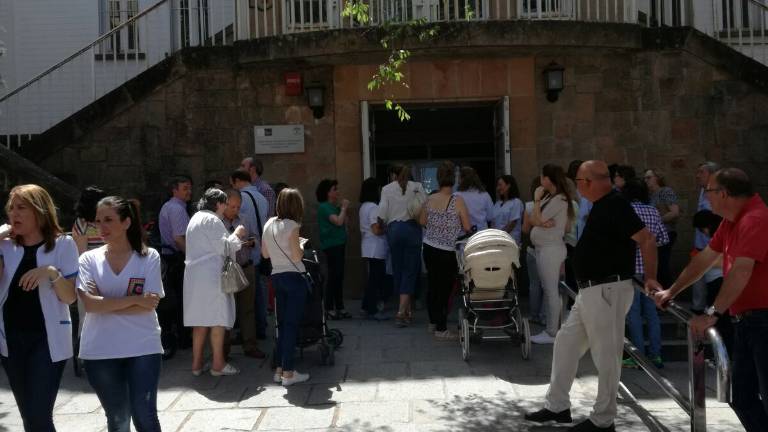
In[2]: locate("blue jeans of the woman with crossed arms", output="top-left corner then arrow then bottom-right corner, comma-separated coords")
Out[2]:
85,354 -> 162,432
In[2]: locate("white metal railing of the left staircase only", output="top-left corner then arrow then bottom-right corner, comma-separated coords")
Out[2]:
0,0 -> 238,142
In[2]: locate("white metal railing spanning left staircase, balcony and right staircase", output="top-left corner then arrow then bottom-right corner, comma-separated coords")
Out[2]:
0,0 -> 768,140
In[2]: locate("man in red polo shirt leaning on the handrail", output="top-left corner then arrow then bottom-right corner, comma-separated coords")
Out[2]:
655,168 -> 768,432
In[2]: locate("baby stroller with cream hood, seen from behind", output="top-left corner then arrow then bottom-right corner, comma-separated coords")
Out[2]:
456,229 -> 531,361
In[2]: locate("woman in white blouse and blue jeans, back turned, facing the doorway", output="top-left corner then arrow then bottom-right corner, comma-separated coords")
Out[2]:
379,165 -> 427,327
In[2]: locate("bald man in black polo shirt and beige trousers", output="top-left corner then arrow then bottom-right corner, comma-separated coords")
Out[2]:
525,161 -> 661,432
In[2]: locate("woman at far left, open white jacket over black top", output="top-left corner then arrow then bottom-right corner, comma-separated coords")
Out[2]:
0,184 -> 78,432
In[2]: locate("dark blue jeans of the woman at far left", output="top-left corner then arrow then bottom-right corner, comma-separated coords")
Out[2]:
0,330 -> 67,432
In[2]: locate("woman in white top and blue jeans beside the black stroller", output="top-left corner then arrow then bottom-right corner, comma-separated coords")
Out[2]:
261,188 -> 313,386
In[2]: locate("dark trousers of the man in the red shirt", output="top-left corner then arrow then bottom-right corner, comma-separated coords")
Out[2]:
731,311 -> 768,432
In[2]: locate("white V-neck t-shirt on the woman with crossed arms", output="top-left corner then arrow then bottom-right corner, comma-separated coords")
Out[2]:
77,246 -> 165,360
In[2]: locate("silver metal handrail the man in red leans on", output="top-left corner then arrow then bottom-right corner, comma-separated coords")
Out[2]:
560,279 -> 731,432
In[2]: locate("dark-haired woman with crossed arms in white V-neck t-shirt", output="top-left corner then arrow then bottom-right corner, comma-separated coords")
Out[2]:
77,196 -> 164,432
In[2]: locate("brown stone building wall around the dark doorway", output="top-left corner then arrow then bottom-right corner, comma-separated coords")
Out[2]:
30,22 -> 768,295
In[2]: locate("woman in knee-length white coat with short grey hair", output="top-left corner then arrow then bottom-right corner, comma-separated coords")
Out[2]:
184,188 -> 247,376
